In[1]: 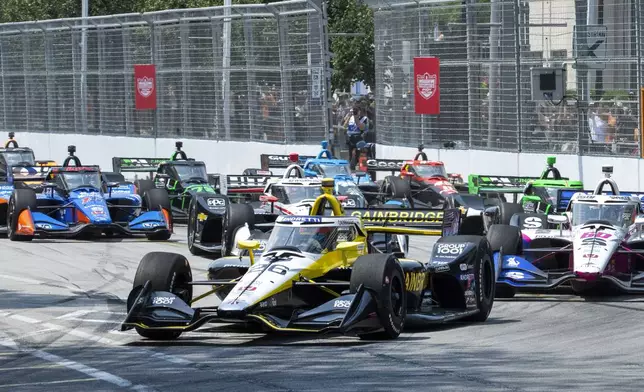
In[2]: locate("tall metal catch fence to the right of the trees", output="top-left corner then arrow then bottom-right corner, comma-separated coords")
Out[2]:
368,0 -> 644,156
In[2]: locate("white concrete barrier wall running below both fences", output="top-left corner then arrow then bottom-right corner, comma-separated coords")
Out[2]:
17,133 -> 644,191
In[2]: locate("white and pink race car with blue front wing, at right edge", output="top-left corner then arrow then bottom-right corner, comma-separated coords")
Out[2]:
487,167 -> 644,297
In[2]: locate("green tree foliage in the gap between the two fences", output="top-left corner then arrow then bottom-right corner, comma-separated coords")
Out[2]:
328,0 -> 376,90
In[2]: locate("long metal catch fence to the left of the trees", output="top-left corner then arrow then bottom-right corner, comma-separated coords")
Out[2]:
0,0 -> 328,143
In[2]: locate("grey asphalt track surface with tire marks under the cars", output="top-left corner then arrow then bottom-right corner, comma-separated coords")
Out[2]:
0,227 -> 644,392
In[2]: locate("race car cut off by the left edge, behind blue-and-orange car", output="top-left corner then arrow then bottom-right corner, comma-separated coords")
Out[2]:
0,132 -> 56,234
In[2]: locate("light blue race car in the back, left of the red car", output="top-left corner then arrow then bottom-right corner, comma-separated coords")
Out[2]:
261,141 -> 379,195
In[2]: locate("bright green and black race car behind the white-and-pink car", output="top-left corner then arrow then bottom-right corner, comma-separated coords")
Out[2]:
468,157 -> 584,214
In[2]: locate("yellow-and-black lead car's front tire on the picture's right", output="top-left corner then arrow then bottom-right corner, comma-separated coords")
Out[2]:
349,254 -> 407,340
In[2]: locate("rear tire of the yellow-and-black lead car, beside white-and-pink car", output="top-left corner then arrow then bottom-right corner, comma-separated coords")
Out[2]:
465,239 -> 496,323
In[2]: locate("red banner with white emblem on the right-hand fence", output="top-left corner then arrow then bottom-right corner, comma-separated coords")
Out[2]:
414,57 -> 441,115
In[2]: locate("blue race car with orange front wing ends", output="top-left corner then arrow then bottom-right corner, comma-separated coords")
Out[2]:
7,161 -> 172,241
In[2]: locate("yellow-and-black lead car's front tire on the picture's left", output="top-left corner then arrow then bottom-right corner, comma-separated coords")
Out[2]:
127,252 -> 192,340
